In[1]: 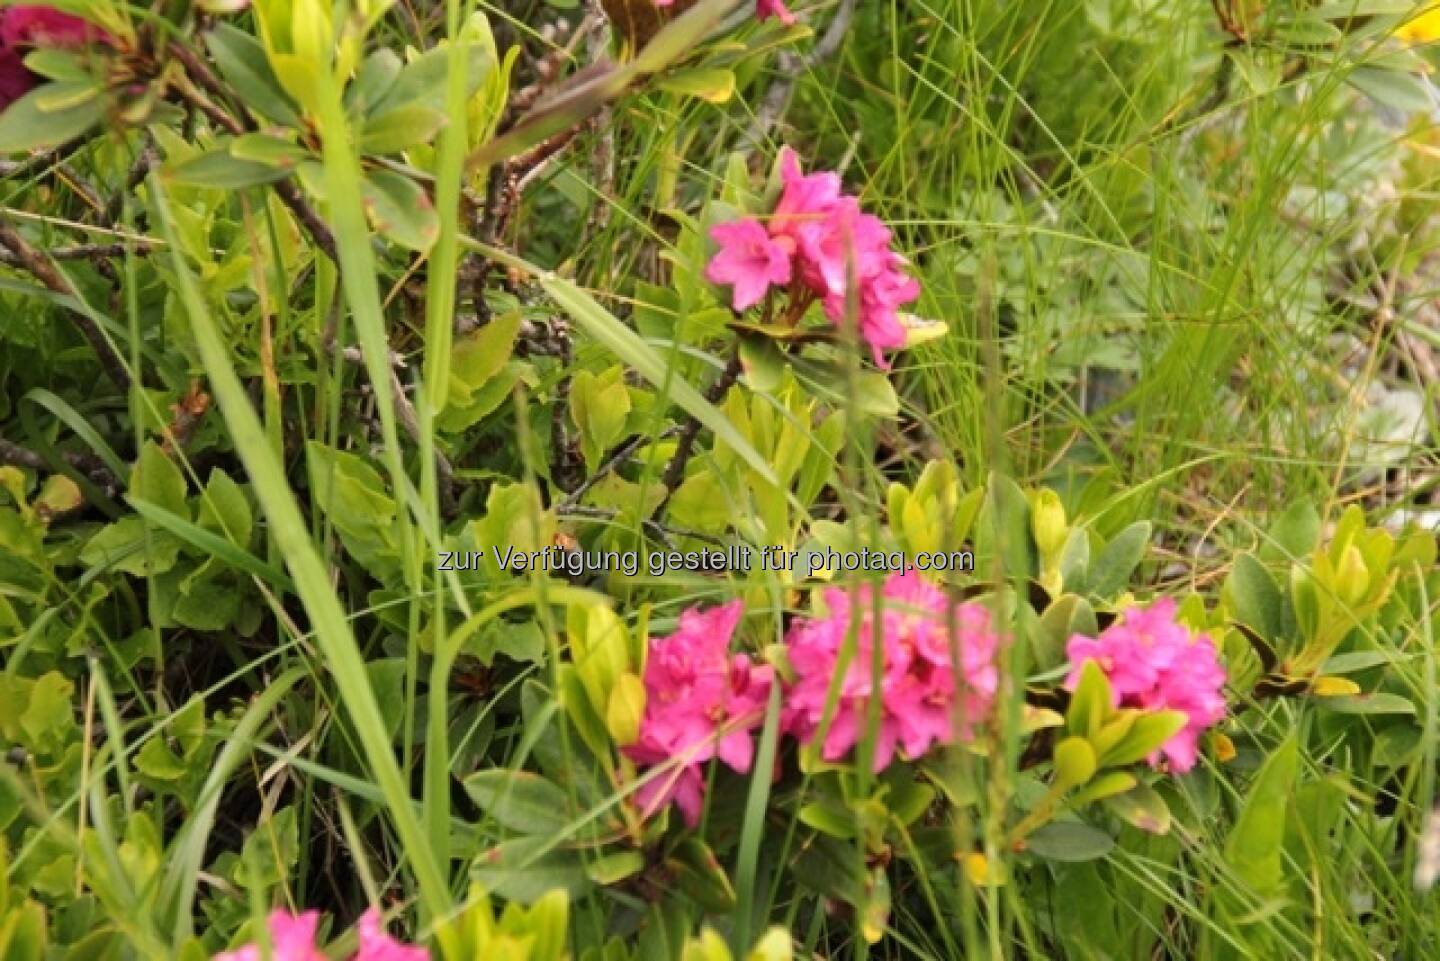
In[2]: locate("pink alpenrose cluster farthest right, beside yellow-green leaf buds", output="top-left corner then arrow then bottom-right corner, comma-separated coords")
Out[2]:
1066,598 -> 1225,774
